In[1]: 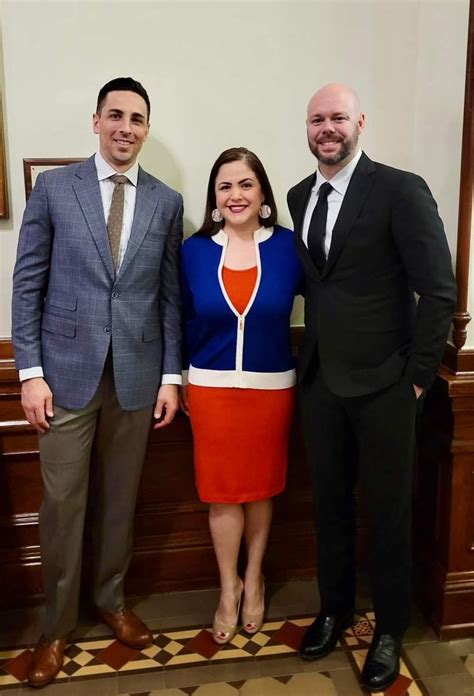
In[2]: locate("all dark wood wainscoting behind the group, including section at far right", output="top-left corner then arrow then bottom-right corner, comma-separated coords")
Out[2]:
0,328 -> 474,637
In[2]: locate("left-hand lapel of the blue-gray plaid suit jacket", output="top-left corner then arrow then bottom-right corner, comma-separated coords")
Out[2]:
73,156 -> 115,280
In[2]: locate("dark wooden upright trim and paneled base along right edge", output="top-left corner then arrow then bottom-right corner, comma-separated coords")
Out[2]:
414,0 -> 474,638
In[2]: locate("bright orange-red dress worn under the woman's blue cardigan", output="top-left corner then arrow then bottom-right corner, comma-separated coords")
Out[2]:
188,267 -> 295,503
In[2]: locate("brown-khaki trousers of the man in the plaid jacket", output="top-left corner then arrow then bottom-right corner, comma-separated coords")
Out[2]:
39,359 -> 153,640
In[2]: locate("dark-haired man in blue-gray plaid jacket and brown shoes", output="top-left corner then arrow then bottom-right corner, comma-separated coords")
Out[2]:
12,78 -> 183,686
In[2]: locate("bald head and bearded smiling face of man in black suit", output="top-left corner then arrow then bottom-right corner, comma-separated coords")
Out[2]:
306,85 -> 365,176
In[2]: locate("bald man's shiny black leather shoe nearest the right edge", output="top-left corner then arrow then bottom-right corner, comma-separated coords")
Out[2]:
362,633 -> 402,691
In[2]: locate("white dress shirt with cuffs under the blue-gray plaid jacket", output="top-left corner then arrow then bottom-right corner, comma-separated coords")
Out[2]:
18,152 -> 181,384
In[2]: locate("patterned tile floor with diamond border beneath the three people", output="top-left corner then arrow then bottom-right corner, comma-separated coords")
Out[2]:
0,581 -> 474,696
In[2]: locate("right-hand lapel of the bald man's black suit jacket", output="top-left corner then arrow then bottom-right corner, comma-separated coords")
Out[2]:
321,153 -> 375,278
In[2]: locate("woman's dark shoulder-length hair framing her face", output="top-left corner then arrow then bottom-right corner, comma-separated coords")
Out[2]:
196,147 -> 278,237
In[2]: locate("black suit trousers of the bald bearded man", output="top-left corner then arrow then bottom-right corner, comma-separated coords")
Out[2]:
300,371 -> 417,635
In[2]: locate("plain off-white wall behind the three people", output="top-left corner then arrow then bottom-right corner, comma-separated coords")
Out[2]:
0,0 -> 466,340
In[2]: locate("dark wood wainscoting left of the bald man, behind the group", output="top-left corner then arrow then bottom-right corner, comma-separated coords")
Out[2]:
0,329 -> 326,606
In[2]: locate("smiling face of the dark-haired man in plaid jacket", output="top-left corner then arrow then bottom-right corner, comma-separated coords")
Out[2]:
92,91 -> 150,172
